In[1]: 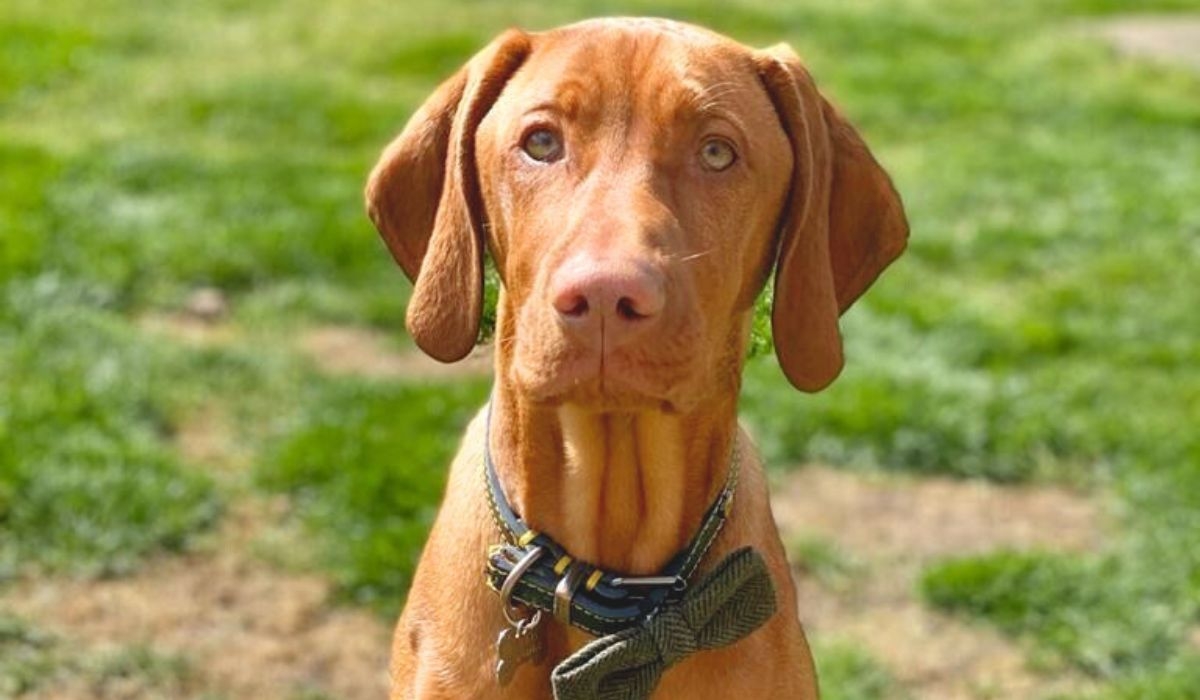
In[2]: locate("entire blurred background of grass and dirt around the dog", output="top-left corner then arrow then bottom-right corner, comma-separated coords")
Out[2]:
0,0 -> 1200,700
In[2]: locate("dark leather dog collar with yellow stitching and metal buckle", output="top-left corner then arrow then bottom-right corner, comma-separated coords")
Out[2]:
484,405 -> 740,636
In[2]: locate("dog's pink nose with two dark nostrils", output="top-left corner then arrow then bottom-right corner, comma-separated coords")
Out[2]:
551,255 -> 666,345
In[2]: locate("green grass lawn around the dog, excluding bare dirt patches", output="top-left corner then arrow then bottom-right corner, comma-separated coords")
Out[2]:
0,0 -> 1200,700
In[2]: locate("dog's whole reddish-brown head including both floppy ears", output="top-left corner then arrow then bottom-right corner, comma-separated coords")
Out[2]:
366,19 -> 908,409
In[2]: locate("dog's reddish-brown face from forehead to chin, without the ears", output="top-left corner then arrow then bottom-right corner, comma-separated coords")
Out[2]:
475,23 -> 792,407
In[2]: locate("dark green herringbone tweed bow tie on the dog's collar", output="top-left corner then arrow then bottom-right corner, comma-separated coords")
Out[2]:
550,548 -> 775,700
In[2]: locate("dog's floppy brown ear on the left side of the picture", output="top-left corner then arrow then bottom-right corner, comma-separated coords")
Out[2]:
366,30 -> 529,363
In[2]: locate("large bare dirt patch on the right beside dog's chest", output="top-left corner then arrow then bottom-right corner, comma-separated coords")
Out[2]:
773,467 -> 1104,700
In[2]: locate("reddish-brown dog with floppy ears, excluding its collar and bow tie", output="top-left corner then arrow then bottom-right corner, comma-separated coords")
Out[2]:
366,19 -> 908,700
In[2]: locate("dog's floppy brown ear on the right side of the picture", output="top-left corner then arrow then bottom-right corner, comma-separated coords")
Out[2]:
755,44 -> 908,391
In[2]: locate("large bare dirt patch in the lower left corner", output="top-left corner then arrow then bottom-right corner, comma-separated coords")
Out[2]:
0,501 -> 388,700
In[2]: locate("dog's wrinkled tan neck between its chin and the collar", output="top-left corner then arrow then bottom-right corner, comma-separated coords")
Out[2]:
488,383 -> 737,575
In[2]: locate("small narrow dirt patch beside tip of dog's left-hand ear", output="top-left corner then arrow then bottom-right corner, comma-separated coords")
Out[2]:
300,325 -> 492,379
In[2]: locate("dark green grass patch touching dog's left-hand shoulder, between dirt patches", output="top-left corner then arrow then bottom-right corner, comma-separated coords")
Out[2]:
260,382 -> 487,614
